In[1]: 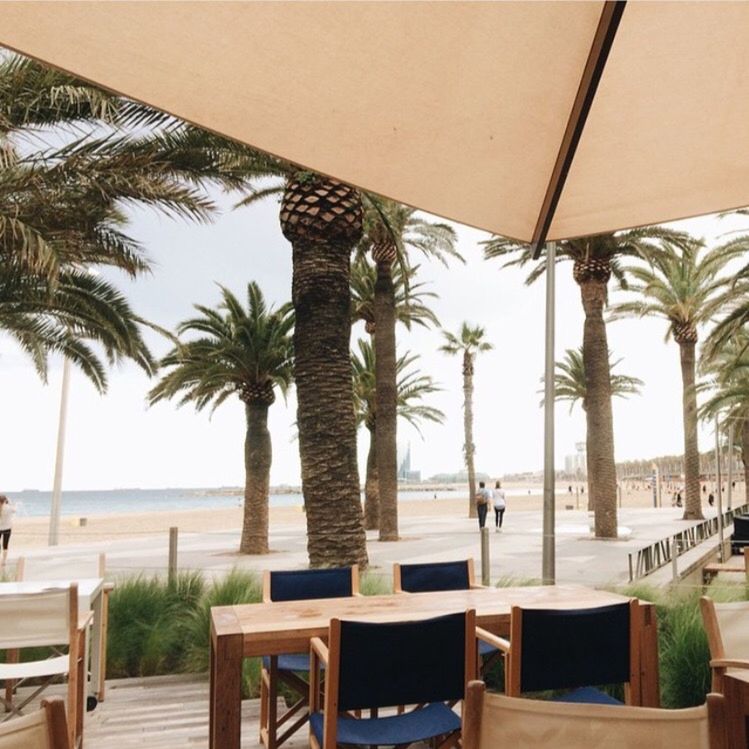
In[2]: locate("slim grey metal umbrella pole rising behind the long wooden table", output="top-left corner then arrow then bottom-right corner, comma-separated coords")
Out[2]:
542,242 -> 556,585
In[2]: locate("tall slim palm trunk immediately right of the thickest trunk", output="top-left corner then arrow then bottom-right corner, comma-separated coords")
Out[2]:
374,262 -> 398,541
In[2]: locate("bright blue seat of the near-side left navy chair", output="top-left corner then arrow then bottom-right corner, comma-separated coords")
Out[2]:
310,702 -> 460,746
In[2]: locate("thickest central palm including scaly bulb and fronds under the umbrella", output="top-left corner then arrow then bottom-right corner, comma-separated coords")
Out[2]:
237,161 -> 368,567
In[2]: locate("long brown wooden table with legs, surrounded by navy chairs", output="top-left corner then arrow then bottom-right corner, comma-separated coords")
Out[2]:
209,585 -> 659,749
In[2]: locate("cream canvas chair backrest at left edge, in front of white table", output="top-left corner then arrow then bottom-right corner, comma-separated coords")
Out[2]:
0,583 -> 78,649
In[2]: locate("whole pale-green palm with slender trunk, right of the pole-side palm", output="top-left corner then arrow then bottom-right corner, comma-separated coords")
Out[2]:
614,239 -> 738,520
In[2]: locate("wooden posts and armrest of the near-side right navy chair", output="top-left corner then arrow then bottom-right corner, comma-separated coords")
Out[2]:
476,598 -> 642,705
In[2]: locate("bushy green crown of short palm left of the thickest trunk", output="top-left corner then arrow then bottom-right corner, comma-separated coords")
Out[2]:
149,282 -> 293,410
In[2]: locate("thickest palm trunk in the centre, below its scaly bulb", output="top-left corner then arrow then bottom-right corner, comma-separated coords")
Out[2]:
292,240 -> 367,567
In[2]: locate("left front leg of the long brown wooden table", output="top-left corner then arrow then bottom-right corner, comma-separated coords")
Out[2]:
208,634 -> 242,749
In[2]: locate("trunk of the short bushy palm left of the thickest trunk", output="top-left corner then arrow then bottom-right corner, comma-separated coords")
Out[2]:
239,401 -> 273,554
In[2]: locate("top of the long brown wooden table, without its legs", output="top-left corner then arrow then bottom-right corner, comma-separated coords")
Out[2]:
211,585 -> 629,656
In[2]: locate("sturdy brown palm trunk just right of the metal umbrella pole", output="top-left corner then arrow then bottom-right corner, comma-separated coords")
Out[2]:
580,278 -> 617,538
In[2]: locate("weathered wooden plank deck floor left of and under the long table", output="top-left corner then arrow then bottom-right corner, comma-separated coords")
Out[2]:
84,675 -> 300,749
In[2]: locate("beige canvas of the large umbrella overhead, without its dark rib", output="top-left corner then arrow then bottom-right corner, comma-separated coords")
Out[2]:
0,0 -> 749,240
